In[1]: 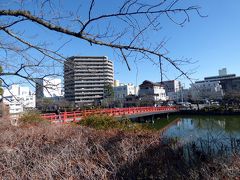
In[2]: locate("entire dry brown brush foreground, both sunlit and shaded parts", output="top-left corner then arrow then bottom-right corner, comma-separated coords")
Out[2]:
0,116 -> 240,179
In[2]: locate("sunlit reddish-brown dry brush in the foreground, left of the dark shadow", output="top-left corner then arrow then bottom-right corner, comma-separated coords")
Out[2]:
0,119 -> 160,179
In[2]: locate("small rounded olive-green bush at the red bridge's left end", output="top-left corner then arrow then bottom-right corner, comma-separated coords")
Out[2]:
19,111 -> 48,125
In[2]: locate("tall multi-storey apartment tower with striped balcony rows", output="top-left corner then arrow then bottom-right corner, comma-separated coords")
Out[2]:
64,56 -> 113,105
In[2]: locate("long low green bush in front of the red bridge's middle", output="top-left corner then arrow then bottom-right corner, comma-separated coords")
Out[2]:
78,115 -> 148,131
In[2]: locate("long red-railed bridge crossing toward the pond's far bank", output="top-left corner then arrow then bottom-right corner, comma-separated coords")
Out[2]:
42,106 -> 179,123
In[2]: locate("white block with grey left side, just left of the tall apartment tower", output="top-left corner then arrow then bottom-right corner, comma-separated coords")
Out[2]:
36,77 -> 63,99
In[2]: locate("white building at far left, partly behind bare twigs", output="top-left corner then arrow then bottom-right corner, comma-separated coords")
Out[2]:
3,84 -> 36,114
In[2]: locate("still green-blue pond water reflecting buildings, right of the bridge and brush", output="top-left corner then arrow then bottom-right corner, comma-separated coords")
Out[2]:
151,116 -> 240,152
